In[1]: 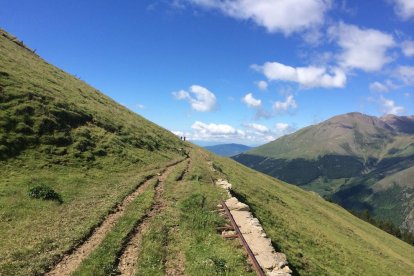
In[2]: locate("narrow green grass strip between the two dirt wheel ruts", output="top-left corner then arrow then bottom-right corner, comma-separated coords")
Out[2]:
73,179 -> 158,276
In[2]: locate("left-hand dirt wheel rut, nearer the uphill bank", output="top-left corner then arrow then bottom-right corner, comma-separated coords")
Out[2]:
45,160 -> 184,276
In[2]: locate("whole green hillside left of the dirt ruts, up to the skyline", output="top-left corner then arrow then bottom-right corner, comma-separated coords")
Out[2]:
0,29 -> 186,275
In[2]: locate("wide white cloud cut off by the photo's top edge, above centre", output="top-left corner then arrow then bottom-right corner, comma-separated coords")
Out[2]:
187,0 -> 331,35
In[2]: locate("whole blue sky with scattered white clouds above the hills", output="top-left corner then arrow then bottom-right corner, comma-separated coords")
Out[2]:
0,0 -> 414,145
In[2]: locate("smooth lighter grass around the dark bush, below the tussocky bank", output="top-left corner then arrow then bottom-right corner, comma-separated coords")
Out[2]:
0,154 -> 170,275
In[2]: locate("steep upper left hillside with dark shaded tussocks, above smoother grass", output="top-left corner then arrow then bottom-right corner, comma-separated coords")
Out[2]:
0,29 -> 183,162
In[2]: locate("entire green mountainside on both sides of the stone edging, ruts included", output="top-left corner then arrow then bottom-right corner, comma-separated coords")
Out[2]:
0,31 -> 414,275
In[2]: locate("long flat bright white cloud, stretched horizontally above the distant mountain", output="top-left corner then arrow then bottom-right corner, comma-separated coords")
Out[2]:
252,62 -> 346,88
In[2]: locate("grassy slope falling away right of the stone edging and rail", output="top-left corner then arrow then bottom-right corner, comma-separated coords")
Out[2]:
213,154 -> 414,275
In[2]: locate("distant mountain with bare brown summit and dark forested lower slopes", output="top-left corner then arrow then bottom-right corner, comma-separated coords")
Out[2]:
234,113 -> 414,232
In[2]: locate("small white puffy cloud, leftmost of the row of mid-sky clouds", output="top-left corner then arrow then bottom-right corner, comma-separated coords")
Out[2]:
172,85 -> 216,112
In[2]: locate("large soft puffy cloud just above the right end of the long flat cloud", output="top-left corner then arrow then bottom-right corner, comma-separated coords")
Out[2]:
329,23 -> 396,72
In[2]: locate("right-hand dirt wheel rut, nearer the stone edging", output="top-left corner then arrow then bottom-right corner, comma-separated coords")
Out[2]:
118,161 -> 187,276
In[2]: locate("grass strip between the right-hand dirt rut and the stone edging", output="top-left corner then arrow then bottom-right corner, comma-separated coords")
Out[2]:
137,149 -> 254,275
